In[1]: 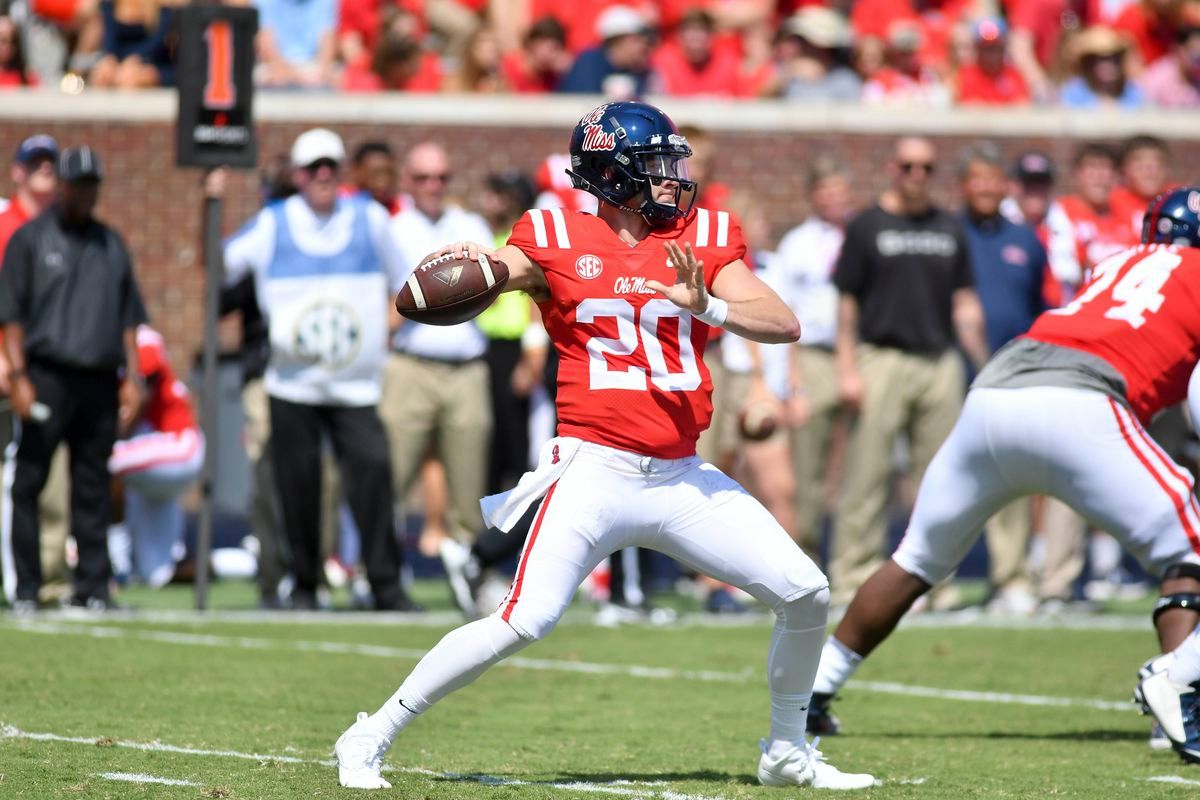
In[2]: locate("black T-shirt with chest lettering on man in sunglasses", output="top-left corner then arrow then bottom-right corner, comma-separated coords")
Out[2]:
834,206 -> 974,355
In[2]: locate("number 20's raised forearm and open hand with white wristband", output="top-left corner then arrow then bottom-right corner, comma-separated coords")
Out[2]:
646,242 -> 800,344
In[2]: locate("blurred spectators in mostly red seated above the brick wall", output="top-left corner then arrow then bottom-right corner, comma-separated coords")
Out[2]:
0,0 -> 1200,109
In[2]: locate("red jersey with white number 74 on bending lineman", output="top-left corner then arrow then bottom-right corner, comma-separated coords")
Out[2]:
1027,245 -> 1200,422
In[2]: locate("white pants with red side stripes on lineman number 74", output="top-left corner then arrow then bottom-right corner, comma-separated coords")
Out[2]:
892,386 -> 1200,584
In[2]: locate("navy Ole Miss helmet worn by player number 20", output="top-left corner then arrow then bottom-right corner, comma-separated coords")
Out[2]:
566,102 -> 696,228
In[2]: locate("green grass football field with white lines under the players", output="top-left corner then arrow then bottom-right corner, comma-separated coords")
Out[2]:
0,584 -> 1200,800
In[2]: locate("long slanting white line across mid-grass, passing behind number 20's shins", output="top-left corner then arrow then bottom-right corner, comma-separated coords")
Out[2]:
6,620 -> 1136,711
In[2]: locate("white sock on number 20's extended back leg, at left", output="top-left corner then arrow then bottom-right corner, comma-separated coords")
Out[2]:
367,615 -> 529,741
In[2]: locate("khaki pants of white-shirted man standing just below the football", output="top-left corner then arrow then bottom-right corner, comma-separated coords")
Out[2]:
379,353 -> 484,542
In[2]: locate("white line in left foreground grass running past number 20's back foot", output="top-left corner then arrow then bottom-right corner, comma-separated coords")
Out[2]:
0,722 -> 725,800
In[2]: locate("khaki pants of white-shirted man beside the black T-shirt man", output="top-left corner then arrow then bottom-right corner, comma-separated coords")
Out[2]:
791,347 -> 840,559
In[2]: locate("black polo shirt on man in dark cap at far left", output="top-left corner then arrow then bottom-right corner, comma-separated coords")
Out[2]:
0,207 -> 146,369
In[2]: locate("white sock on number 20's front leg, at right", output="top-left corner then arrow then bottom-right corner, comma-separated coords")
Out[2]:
767,589 -> 829,756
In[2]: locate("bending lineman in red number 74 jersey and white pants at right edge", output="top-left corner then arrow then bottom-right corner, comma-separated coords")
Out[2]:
814,187 -> 1200,728
